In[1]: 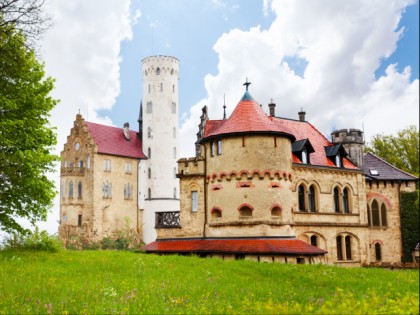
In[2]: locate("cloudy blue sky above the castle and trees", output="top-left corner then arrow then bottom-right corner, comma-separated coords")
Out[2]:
14,0 -> 419,233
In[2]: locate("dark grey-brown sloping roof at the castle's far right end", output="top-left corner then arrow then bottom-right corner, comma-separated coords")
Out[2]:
363,152 -> 419,181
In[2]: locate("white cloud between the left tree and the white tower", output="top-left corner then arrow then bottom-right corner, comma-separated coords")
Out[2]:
35,0 -> 136,232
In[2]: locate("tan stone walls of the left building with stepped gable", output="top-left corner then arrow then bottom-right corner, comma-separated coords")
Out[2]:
59,115 -> 141,246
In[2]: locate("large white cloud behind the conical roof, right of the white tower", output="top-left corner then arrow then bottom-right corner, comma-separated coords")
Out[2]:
181,0 -> 419,155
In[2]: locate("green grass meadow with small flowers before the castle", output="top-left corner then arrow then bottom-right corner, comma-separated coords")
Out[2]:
0,250 -> 419,314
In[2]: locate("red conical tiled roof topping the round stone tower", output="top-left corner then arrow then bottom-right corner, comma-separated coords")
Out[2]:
204,91 -> 294,140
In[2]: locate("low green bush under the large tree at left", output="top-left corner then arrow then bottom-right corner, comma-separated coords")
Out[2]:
3,227 -> 62,252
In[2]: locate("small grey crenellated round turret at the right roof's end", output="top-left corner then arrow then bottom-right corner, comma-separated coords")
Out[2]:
331,129 -> 365,168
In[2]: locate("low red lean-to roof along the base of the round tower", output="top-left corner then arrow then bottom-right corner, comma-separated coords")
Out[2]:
142,238 -> 327,255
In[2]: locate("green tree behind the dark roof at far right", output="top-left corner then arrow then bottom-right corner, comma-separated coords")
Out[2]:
366,125 -> 419,177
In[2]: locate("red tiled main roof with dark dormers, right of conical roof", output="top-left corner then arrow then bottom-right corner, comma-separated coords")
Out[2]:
273,117 -> 358,169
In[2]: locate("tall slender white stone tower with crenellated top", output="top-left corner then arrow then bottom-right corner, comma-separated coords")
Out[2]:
139,55 -> 180,243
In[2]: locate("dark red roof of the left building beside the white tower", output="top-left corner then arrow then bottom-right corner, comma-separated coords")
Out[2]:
86,122 -> 146,159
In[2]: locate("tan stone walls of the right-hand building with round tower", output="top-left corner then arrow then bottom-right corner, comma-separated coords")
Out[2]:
158,89 -> 417,267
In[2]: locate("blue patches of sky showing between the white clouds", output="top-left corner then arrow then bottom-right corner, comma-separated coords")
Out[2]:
100,0 -> 419,139
